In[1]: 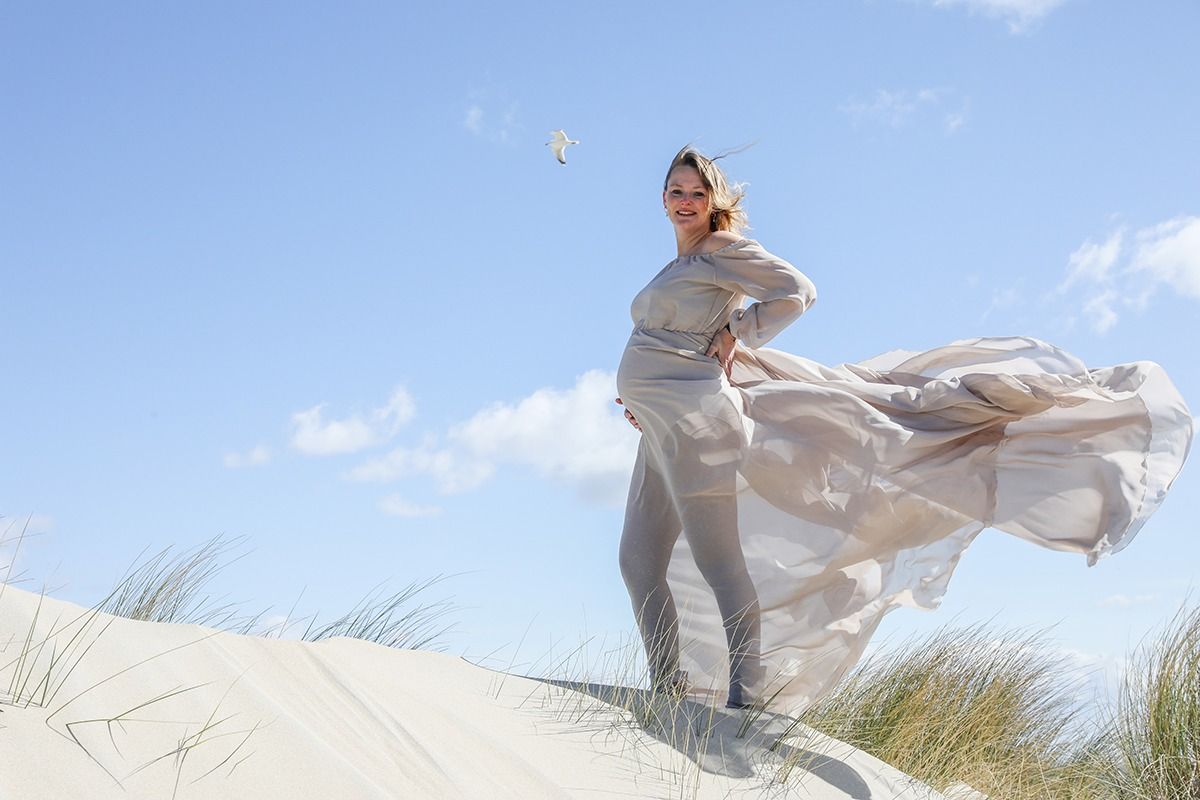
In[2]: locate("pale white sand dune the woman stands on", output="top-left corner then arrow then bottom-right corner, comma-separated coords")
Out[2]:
0,587 -> 955,800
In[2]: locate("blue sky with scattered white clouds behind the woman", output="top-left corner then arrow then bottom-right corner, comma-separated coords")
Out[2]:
0,0 -> 1200,705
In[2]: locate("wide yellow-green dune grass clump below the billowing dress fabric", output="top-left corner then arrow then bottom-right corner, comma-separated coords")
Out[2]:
782,624 -> 1105,800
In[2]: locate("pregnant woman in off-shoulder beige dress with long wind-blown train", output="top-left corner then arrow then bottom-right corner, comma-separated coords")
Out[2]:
617,148 -> 1193,710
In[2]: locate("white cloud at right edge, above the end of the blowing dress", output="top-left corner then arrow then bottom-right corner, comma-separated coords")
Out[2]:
1052,216 -> 1200,333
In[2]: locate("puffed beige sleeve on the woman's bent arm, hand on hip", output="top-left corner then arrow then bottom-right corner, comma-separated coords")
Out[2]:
714,239 -> 817,348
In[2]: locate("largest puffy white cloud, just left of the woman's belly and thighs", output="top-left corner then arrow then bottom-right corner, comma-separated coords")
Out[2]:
347,369 -> 637,506
